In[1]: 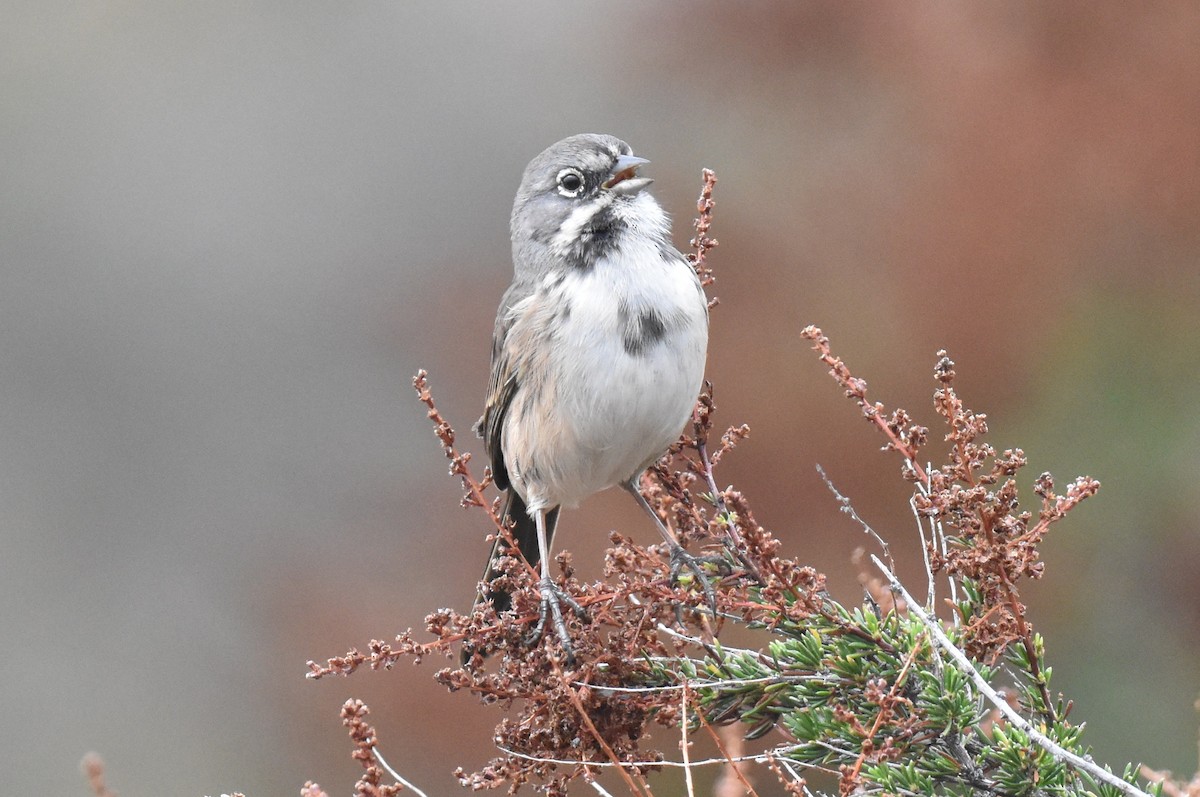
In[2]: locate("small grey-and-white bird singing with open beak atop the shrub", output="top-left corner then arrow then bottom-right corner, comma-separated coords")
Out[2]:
464,133 -> 712,659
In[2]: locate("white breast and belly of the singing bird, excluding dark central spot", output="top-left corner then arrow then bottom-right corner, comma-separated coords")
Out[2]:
505,224 -> 708,508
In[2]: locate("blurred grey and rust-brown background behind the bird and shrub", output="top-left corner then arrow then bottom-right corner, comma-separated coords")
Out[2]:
0,0 -> 1200,797
